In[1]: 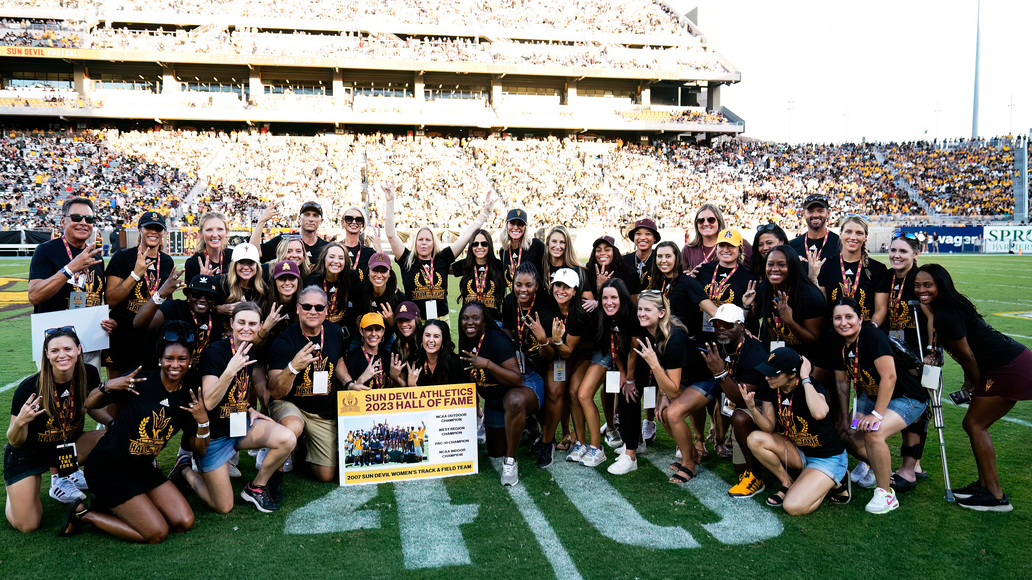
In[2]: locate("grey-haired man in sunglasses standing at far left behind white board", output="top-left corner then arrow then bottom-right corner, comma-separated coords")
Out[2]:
29,197 -> 116,370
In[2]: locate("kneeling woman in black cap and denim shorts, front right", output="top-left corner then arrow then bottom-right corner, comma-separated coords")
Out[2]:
740,347 -> 849,516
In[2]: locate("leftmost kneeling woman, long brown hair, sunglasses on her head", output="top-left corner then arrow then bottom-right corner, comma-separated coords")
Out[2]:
3,327 -> 104,533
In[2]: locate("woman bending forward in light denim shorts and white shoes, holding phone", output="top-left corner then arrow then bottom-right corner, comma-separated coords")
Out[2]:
832,297 -> 928,514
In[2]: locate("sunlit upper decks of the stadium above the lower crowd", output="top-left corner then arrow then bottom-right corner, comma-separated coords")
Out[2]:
0,0 -> 744,138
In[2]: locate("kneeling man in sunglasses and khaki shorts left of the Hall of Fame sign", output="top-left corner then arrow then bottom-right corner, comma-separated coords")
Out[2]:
268,286 -> 345,482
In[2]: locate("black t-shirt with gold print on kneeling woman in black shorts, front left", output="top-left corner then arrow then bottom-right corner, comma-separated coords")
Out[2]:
90,370 -> 198,468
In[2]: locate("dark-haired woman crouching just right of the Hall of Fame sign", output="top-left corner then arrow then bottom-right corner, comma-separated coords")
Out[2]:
458,302 -> 524,485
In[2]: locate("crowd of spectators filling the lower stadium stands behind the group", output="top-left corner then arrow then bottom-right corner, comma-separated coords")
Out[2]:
0,130 -> 1014,233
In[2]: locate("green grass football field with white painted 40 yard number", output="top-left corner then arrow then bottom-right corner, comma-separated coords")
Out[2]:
0,256 -> 1032,580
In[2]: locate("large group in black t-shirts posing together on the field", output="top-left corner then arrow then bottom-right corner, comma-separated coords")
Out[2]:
4,171 -> 1032,542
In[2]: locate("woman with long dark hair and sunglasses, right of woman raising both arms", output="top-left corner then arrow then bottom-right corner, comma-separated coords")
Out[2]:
452,229 -> 509,321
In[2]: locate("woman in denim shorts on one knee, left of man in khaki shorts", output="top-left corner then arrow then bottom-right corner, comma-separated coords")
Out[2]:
168,302 -> 297,514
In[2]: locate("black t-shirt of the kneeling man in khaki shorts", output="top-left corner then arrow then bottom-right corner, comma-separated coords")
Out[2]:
268,323 -> 344,419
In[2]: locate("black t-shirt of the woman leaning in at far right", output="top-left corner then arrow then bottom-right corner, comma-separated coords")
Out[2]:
932,308 -> 1025,375
